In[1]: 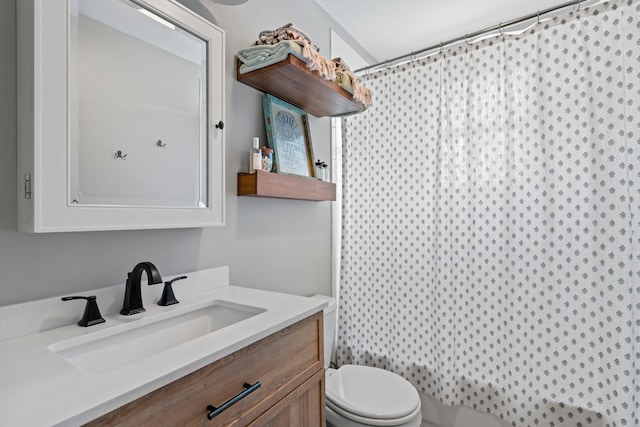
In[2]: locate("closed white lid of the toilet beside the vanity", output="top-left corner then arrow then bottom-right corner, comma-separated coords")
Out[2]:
326,365 -> 420,420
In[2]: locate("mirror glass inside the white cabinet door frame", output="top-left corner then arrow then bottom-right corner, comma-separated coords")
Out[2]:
68,0 -> 209,208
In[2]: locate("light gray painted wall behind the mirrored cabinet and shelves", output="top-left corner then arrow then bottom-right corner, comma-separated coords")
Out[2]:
0,0 -> 364,305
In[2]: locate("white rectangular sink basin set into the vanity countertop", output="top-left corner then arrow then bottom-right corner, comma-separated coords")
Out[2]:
49,300 -> 266,374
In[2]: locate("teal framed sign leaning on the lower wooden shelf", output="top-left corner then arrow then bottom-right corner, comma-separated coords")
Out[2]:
262,94 -> 316,178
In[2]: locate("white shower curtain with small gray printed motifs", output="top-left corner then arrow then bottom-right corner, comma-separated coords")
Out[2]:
336,0 -> 640,426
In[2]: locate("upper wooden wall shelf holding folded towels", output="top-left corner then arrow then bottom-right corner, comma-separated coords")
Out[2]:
236,54 -> 365,117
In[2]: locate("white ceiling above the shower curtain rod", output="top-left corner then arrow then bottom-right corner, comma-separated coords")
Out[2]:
315,0 -> 568,62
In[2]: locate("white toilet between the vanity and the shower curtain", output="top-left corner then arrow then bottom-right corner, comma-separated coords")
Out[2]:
313,295 -> 422,427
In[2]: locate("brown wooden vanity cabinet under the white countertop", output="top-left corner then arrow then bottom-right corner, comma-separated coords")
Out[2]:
87,312 -> 325,427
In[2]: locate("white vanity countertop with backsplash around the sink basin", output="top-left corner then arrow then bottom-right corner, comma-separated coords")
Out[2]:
0,267 -> 326,426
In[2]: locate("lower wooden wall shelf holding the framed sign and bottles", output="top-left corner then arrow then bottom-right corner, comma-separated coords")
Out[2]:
238,171 -> 336,201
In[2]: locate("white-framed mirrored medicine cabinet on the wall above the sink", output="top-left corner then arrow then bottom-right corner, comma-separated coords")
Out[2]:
18,0 -> 224,232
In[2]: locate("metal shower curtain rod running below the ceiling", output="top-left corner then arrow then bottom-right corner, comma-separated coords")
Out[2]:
354,0 -> 610,74
